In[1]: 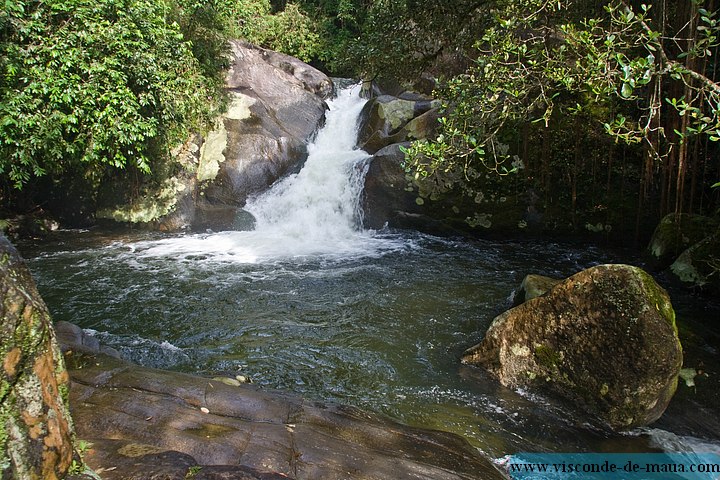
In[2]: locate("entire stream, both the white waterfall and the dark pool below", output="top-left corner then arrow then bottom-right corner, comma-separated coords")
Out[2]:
18,84 -> 720,466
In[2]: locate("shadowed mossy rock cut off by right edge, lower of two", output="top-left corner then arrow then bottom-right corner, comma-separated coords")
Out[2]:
670,229 -> 720,295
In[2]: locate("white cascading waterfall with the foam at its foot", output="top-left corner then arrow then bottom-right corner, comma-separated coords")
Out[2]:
133,85 -> 400,263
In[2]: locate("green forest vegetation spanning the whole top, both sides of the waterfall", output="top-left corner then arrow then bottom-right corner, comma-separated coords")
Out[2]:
0,0 -> 720,242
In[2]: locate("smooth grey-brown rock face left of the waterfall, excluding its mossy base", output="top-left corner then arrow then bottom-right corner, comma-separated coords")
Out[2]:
198,41 -> 332,218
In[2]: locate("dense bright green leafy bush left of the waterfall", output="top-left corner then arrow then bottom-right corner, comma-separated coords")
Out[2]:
0,0 -> 222,188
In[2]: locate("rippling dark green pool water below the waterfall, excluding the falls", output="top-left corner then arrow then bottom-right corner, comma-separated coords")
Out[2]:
21,232 -> 717,457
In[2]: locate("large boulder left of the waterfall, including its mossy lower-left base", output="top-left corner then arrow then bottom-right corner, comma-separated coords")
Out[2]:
96,40 -> 333,230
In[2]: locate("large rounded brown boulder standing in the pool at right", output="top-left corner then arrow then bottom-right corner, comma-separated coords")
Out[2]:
462,265 -> 682,430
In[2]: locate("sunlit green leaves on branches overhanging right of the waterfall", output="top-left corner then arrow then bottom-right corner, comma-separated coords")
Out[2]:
408,0 -> 720,210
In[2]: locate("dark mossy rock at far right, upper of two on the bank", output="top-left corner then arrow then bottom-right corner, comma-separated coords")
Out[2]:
647,213 -> 718,269
